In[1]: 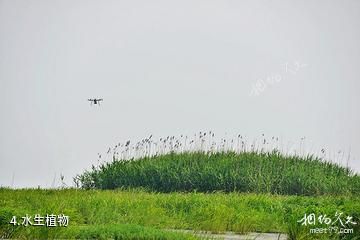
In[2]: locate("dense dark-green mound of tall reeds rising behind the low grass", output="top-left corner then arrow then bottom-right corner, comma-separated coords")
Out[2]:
75,151 -> 360,195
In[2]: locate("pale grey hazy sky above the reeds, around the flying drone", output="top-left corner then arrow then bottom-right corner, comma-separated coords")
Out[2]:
0,0 -> 360,187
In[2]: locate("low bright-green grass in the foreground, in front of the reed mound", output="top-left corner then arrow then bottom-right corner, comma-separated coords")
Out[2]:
0,188 -> 360,239
